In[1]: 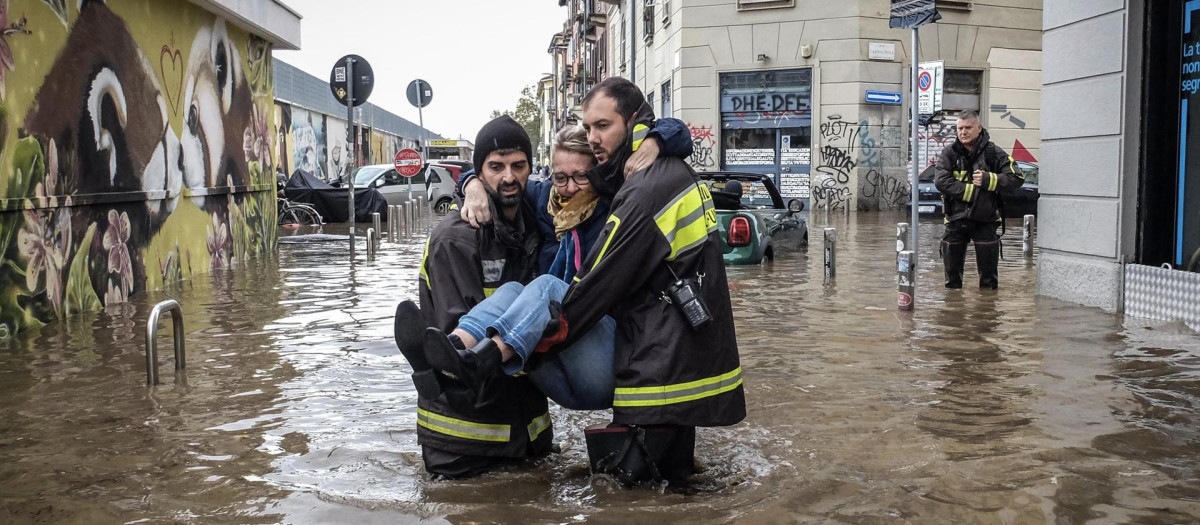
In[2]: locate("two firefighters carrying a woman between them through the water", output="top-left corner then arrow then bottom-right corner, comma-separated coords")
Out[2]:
396,78 -> 745,484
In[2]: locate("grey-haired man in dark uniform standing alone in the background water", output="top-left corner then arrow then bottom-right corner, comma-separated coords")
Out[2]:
934,110 -> 1025,290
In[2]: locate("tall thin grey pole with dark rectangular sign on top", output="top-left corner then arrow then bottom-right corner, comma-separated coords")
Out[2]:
888,0 -> 942,309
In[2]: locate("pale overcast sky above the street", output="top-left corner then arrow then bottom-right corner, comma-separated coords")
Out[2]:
275,0 -> 566,141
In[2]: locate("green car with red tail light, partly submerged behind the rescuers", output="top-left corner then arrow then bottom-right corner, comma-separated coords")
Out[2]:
697,171 -> 809,265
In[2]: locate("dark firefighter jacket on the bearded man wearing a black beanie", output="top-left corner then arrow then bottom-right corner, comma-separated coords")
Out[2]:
416,198 -> 553,458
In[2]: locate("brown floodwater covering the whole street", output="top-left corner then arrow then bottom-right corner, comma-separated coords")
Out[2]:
0,213 -> 1200,525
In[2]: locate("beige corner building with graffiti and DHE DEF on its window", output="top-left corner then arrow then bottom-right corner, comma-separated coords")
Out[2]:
552,0 -> 1042,210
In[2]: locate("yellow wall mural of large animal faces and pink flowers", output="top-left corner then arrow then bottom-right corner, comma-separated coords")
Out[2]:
0,0 -> 276,337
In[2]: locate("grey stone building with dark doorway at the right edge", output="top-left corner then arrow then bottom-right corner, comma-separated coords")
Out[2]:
1038,0 -> 1200,330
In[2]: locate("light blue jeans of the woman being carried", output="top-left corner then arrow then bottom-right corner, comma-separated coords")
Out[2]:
458,276 -> 617,410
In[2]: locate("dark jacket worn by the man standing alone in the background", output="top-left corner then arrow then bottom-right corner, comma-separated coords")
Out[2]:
934,129 -> 1025,223
